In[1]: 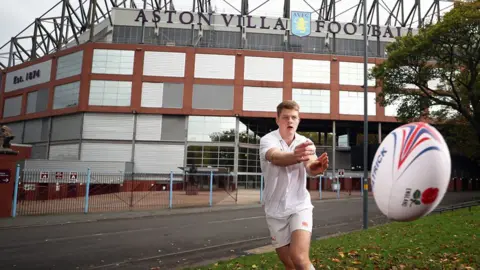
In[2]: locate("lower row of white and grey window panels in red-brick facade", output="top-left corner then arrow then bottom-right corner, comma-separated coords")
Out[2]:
3,80 -> 396,118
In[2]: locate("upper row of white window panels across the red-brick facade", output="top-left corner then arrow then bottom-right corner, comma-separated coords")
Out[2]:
5,49 -> 375,95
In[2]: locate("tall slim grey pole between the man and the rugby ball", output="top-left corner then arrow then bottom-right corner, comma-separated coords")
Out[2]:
363,0 -> 368,230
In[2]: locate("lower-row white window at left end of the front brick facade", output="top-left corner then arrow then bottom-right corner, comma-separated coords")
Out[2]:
88,81 -> 132,106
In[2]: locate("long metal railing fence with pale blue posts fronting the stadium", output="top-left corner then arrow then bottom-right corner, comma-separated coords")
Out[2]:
12,163 -> 480,217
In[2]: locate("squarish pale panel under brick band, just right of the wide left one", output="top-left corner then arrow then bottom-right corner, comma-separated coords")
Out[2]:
135,114 -> 162,141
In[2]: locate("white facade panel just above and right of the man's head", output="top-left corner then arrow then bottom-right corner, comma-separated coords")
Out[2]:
292,88 -> 330,113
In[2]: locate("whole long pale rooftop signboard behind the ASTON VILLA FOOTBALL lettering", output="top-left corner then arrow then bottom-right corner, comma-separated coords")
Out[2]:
126,9 -> 418,40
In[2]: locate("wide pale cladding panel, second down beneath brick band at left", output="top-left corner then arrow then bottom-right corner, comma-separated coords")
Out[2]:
81,142 -> 132,162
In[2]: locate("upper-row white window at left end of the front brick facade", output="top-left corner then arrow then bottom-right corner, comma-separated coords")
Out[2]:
92,49 -> 135,75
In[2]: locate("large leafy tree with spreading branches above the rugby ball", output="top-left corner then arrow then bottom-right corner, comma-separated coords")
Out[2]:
372,0 -> 480,142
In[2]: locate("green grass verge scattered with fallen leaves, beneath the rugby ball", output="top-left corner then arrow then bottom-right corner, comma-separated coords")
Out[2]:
187,207 -> 480,270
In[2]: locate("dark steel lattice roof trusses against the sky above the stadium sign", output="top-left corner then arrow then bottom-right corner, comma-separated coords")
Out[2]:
0,0 -> 454,69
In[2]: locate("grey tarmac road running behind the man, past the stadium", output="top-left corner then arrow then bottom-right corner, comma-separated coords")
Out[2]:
0,192 -> 480,269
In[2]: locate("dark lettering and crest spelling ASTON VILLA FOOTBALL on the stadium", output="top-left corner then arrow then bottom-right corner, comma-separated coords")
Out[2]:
135,9 -> 413,39
